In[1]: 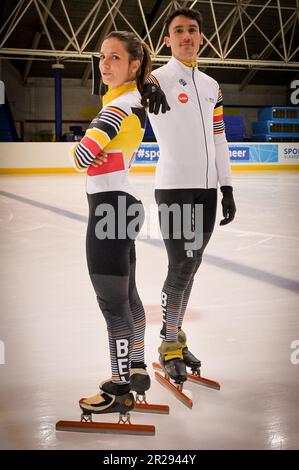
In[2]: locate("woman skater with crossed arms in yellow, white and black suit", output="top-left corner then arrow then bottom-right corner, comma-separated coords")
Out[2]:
72,31 -> 155,415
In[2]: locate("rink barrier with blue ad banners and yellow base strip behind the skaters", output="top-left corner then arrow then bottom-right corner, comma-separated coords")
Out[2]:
0,142 -> 299,174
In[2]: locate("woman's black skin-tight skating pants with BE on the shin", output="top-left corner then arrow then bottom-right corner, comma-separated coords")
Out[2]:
86,191 -> 145,383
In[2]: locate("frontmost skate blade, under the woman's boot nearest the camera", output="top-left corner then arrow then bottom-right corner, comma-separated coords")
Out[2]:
56,421 -> 156,436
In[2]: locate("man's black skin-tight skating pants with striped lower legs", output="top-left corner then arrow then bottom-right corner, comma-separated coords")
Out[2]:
155,189 -> 217,341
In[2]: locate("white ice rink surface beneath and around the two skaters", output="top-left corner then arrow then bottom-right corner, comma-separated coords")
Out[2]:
0,171 -> 299,451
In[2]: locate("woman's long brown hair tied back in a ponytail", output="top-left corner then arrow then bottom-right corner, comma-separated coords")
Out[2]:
105,31 -> 152,92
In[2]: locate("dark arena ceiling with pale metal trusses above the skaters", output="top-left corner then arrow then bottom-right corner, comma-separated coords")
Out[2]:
0,0 -> 299,89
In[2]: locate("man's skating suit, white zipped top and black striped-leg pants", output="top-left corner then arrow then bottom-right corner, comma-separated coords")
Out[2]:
149,57 -> 231,341
